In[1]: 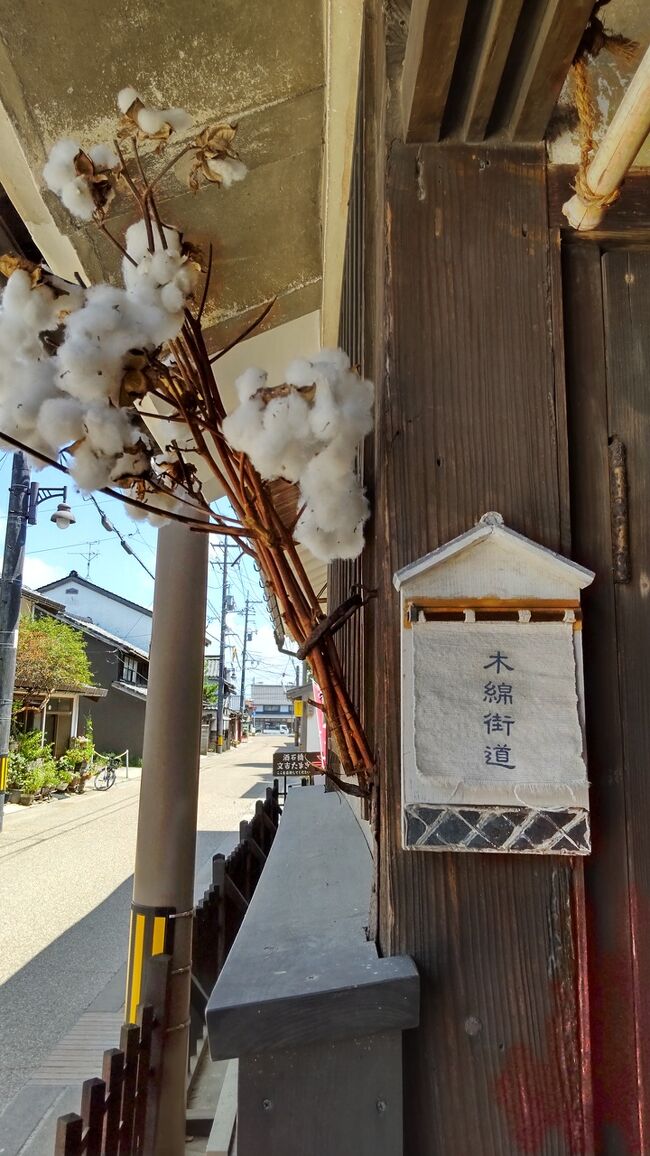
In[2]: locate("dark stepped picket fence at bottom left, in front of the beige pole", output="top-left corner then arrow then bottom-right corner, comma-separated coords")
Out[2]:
54,955 -> 171,1156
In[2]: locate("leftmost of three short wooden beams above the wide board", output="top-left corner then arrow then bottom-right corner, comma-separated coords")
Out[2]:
401,0 -> 467,141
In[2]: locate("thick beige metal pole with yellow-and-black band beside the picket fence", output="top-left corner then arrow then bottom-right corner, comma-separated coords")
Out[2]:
126,523 -> 208,1156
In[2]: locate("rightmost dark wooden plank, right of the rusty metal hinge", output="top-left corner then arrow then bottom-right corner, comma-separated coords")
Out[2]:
603,250 -> 650,1147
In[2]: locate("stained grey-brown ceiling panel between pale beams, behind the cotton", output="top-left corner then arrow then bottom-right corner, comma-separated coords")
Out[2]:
0,0 -> 324,343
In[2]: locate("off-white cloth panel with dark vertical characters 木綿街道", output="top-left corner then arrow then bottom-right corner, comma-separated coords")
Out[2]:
405,622 -> 588,809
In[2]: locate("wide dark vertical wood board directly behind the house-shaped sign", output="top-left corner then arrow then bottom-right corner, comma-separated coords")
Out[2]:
375,146 -> 589,1156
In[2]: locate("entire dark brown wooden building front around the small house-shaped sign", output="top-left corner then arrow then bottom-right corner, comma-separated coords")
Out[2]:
330,0 -> 650,1156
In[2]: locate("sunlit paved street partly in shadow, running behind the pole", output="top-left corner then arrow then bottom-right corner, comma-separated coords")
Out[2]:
0,735 -> 287,1113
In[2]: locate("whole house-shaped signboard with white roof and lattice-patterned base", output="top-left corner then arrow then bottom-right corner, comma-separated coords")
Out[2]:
396,513 -> 593,854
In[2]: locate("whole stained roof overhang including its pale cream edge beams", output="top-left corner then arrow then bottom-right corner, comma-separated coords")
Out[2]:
0,0 -> 363,624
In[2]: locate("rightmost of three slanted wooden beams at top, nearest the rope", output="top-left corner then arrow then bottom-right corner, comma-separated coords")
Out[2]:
492,0 -> 593,142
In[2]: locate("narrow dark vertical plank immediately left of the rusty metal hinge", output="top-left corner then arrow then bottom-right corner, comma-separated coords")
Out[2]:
562,242 -> 629,1153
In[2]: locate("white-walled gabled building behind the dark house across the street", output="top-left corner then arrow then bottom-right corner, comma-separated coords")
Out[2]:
39,570 -> 153,654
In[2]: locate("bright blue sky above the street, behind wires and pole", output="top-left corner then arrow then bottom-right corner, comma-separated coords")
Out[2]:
0,453 -> 294,689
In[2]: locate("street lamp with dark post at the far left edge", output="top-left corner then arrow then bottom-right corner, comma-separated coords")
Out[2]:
0,453 -> 76,831
